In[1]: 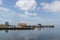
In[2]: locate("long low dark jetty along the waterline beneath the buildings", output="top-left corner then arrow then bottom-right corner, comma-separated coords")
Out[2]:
0,25 -> 54,30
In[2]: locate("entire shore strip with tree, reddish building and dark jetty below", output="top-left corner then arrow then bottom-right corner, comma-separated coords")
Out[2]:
0,22 -> 54,30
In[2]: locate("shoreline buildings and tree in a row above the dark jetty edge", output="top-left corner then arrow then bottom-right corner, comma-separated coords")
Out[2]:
0,22 -> 54,28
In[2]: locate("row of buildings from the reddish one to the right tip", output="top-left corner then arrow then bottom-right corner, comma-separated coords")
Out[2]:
17,23 -> 54,28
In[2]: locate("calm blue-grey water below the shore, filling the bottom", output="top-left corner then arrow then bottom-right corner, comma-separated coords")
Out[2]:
0,26 -> 60,40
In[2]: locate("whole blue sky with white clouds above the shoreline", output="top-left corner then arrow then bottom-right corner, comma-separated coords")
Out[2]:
0,0 -> 60,25
